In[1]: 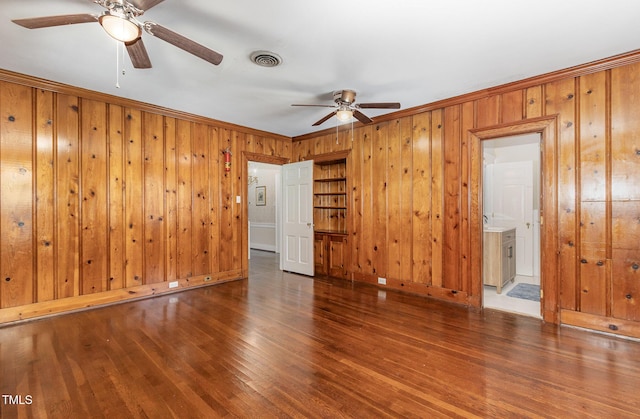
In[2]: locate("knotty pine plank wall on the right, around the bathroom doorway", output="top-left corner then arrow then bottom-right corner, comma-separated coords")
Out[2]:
293,52 -> 640,337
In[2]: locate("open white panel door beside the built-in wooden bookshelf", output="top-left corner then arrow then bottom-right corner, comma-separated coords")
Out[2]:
280,160 -> 313,276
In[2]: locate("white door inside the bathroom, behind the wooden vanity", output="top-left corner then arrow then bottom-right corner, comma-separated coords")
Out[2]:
491,161 -> 534,276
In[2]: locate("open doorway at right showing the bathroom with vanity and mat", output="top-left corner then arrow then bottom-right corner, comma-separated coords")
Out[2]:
482,133 -> 541,317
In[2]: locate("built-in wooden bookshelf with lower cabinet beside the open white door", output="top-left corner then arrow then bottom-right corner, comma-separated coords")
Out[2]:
313,152 -> 349,278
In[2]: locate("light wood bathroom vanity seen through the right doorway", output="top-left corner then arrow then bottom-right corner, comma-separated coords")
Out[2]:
482,227 -> 516,294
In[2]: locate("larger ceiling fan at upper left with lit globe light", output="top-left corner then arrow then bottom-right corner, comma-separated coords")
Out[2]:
12,0 -> 222,68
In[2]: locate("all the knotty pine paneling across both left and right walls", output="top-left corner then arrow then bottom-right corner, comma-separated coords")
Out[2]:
0,52 -> 640,337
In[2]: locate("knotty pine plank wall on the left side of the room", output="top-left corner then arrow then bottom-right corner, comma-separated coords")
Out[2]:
0,73 -> 291,323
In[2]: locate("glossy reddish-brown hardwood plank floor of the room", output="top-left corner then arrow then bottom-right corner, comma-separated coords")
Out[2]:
0,251 -> 640,418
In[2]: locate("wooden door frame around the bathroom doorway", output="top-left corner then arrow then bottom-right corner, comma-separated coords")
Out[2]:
468,115 -> 560,324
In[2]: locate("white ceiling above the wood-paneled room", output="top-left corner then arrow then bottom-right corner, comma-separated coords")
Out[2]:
0,0 -> 640,136
